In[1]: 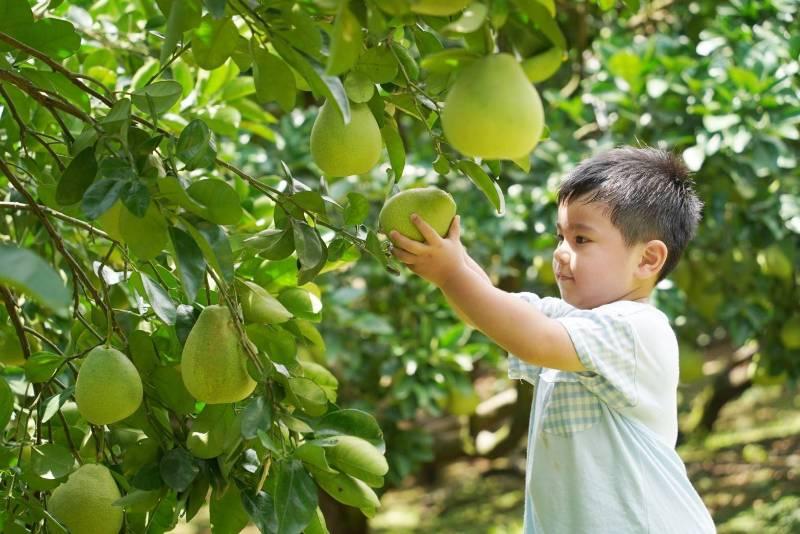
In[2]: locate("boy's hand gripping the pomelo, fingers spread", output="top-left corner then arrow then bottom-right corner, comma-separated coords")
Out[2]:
389,214 -> 468,287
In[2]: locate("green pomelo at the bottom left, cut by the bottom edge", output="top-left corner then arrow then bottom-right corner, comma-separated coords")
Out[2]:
47,464 -> 123,534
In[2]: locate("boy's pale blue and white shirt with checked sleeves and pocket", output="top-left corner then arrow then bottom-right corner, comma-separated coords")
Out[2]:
508,293 -> 716,534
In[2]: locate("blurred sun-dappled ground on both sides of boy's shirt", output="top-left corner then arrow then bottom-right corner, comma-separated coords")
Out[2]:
371,386 -> 800,534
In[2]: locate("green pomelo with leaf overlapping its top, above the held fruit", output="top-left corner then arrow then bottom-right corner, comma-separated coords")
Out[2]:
311,102 -> 382,176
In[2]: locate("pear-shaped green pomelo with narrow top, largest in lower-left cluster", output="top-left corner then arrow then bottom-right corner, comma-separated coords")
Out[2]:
181,304 -> 256,404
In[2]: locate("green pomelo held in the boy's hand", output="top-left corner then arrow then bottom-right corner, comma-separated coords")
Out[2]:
378,186 -> 456,242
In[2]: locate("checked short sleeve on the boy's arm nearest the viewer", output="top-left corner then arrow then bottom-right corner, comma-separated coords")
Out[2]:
557,310 -> 638,409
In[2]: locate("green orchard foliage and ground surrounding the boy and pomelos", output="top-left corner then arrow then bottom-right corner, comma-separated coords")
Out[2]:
0,0 -> 800,533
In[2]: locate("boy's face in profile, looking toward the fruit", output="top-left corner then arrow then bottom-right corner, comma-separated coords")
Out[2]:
553,199 -> 650,309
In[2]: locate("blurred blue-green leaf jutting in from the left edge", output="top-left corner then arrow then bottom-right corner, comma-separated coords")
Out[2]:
0,245 -> 70,314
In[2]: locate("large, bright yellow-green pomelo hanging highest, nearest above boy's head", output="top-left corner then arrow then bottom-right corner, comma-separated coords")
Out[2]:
442,54 -> 544,160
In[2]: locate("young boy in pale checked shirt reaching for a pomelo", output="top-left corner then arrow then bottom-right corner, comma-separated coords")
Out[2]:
390,147 -> 715,534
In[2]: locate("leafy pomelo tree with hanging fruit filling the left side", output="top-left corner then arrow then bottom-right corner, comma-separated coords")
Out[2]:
0,0 -> 638,532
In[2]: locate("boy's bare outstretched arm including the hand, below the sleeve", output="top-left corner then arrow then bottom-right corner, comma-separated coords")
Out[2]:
389,216 -> 586,371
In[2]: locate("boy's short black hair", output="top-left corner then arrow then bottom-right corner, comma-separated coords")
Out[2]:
558,147 -> 703,282
